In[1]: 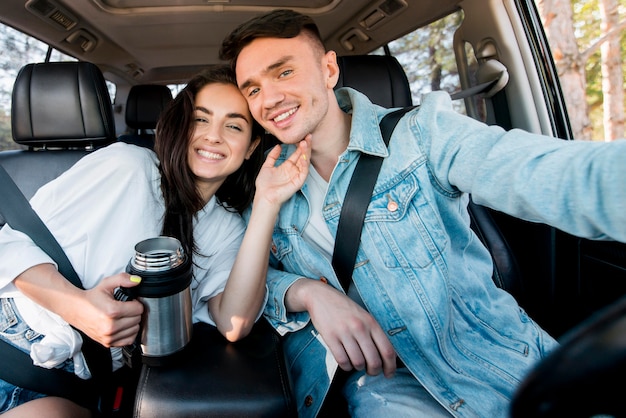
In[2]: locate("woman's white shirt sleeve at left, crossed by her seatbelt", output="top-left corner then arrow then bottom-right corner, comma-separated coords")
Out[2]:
0,143 -> 162,295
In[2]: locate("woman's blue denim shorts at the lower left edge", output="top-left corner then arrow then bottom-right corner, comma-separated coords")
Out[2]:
0,298 -> 74,414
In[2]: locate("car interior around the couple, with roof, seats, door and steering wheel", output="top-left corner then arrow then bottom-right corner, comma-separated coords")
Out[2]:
0,0 -> 626,417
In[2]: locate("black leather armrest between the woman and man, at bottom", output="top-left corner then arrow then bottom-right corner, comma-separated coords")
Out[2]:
133,318 -> 296,418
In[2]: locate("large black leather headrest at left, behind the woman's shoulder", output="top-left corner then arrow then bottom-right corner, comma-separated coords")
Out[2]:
11,62 -> 116,147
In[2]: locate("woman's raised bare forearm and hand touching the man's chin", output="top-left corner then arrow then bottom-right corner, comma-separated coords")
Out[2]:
209,135 -> 310,341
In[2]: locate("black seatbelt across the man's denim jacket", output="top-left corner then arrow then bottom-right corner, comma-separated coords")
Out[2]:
332,106 -> 416,292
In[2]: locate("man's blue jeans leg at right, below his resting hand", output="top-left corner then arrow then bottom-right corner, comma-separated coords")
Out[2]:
343,367 -> 452,418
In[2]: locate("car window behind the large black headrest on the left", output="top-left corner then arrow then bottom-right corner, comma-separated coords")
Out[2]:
0,22 -> 115,151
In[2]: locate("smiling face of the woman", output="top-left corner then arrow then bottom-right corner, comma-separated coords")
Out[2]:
187,83 -> 258,202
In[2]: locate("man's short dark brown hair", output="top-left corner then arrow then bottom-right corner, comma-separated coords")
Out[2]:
220,9 -> 324,68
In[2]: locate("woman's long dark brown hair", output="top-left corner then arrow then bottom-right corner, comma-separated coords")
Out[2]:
154,65 -> 272,254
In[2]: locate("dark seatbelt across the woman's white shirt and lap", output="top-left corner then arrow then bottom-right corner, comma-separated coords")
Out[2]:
0,165 -> 112,403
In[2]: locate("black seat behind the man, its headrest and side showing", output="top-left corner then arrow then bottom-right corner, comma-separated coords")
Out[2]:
335,55 -> 524,299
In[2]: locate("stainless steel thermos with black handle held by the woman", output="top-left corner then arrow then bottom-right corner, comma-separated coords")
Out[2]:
125,236 -> 193,365
